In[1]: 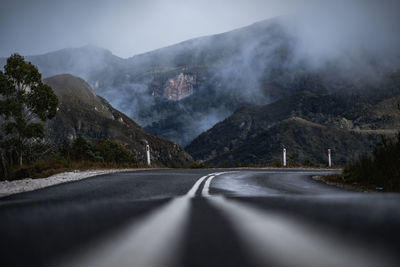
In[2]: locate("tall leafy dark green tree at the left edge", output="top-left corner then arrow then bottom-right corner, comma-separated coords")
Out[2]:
0,54 -> 58,169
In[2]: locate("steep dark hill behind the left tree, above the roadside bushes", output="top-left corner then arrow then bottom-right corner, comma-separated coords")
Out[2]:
44,74 -> 192,167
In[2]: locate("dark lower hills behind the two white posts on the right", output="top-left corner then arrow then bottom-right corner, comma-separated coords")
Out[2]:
186,91 -> 400,166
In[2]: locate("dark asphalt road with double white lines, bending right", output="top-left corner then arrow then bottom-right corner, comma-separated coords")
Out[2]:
0,169 -> 400,267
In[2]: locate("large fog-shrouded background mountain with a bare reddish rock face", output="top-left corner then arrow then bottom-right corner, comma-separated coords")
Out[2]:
3,14 -> 400,145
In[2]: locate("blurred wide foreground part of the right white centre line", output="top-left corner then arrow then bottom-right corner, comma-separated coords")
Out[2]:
208,197 -> 393,267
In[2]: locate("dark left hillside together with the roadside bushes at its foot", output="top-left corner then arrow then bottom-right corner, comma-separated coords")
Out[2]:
0,71 -> 192,179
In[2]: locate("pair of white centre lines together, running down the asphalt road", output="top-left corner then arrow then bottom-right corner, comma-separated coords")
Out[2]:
61,172 -> 368,267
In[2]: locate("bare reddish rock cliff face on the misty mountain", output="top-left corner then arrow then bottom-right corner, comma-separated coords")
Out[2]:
164,73 -> 196,101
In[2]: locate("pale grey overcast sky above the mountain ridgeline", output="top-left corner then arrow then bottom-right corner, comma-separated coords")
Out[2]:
0,0 -> 310,57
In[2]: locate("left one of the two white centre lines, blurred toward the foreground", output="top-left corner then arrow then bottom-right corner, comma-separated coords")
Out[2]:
59,173 -> 220,267
